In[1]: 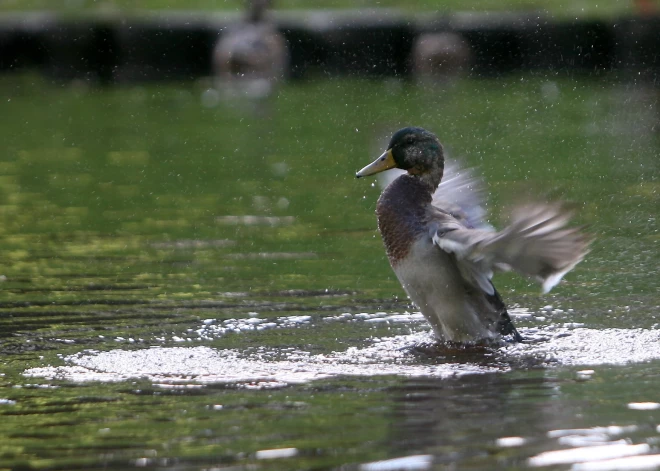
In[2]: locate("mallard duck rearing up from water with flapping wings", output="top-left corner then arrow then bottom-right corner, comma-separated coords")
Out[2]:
356,127 -> 591,344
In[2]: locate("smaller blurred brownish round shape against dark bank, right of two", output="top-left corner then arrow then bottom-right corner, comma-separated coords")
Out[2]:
411,32 -> 473,82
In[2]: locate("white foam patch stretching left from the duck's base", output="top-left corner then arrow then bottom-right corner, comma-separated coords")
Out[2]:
24,333 -> 499,387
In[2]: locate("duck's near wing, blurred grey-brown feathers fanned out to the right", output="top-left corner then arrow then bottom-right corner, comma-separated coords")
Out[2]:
431,204 -> 591,294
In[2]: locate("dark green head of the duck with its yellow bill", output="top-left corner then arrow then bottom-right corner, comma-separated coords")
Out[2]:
355,127 -> 445,186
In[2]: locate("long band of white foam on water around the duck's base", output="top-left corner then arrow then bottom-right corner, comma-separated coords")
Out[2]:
24,326 -> 660,390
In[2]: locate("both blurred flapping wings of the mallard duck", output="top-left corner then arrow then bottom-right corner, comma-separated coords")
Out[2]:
379,163 -> 591,295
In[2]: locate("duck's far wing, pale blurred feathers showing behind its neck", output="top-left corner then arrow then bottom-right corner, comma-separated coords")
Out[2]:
378,160 -> 493,230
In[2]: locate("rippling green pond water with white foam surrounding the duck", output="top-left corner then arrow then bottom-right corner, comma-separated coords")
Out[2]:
0,75 -> 660,471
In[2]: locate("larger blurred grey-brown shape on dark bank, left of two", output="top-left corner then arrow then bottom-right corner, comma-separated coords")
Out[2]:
213,0 -> 289,98
